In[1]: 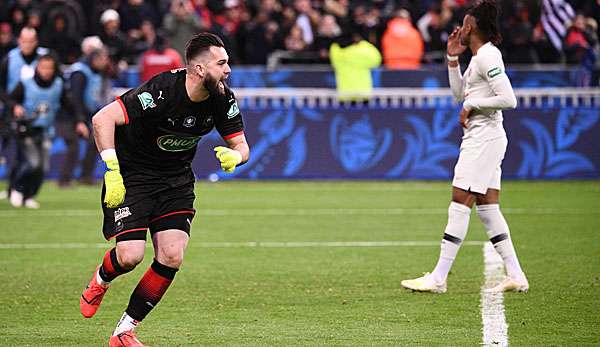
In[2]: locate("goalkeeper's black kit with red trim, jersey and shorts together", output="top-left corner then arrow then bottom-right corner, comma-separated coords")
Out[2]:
102,69 -> 244,241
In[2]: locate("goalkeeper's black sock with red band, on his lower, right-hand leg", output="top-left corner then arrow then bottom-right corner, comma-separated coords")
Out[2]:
125,259 -> 178,321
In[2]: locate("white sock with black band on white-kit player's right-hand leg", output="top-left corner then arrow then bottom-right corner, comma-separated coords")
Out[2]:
477,204 -> 525,281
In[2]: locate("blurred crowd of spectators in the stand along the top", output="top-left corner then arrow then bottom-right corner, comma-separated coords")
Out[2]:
0,0 -> 600,68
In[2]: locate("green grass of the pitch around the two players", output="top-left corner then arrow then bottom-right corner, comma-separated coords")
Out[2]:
0,181 -> 600,346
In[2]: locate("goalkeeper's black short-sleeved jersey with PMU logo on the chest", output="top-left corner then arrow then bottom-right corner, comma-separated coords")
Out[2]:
115,69 -> 244,176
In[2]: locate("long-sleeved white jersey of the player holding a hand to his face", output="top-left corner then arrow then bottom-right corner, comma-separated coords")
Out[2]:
448,42 -> 517,141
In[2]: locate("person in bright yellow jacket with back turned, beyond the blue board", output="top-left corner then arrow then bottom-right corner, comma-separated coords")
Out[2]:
329,30 -> 381,102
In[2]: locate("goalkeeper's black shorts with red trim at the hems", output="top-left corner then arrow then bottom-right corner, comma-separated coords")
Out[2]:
101,175 -> 196,242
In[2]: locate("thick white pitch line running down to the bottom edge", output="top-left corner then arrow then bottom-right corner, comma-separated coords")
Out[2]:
481,242 -> 508,347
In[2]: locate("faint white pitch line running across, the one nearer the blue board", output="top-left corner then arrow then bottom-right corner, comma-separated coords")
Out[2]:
0,207 -> 600,218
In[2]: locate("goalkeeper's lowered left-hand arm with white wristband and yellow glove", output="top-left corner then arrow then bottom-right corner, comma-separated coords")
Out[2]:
92,101 -> 125,208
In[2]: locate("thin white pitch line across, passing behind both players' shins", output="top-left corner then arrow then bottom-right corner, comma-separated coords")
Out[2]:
0,241 -> 484,249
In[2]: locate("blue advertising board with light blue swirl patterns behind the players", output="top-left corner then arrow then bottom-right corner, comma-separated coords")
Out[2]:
7,107 -> 600,180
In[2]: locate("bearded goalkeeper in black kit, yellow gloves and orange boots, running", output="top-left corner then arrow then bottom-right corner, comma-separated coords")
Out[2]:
80,33 -> 249,346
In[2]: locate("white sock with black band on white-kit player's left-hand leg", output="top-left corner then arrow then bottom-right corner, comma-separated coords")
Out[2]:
431,201 -> 471,283
